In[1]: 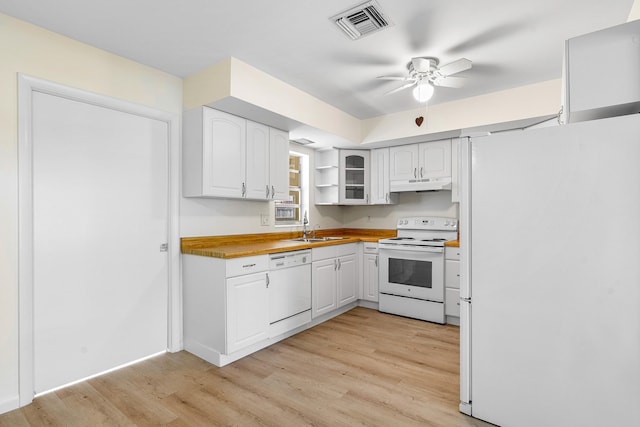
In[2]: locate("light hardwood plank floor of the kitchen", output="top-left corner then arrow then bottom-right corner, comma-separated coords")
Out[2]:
0,307 -> 490,427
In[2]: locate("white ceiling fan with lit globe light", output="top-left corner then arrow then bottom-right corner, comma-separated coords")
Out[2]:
378,56 -> 471,102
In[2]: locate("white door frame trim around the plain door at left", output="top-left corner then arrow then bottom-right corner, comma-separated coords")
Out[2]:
18,73 -> 183,406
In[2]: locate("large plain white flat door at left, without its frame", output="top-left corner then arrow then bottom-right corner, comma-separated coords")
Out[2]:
32,92 -> 169,393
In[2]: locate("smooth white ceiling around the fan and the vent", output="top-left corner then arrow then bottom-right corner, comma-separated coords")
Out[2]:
0,0 -> 633,119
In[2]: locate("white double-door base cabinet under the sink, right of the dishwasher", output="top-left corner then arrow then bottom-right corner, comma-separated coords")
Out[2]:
311,243 -> 359,318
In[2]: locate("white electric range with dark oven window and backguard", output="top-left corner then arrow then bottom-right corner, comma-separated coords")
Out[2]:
378,217 -> 458,323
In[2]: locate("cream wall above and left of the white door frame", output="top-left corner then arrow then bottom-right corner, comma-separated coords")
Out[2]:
0,14 -> 182,413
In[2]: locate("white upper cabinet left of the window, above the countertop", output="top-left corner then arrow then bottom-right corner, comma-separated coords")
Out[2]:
182,107 -> 289,200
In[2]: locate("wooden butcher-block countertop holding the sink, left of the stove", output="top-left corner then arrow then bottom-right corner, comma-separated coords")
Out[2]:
180,228 -> 396,258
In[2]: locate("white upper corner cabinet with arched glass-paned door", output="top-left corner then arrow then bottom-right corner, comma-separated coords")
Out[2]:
339,150 -> 370,205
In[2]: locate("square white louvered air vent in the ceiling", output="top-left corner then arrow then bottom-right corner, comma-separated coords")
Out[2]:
330,1 -> 393,40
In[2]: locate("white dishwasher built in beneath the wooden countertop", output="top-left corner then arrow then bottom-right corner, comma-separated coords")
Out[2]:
267,249 -> 311,325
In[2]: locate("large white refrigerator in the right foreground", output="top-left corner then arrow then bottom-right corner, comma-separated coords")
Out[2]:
460,114 -> 640,427
